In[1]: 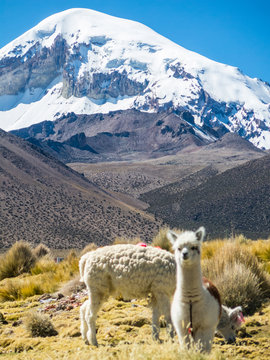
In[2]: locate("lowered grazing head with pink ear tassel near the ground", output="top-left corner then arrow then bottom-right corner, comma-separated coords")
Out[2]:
217,305 -> 245,343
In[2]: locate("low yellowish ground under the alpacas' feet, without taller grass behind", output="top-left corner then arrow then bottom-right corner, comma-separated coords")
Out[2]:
0,292 -> 270,360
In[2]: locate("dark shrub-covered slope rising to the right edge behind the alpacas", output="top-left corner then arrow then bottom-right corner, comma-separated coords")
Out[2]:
141,155 -> 270,239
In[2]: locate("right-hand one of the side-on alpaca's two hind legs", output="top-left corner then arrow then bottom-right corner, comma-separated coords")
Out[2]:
86,292 -> 103,346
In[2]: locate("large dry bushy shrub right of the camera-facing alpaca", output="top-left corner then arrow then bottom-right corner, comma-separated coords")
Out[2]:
202,242 -> 270,314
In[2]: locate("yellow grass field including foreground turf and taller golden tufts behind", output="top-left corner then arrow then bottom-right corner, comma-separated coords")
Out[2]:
0,239 -> 270,360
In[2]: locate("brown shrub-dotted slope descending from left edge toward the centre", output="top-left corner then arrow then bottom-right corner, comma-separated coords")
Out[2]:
0,130 -> 158,248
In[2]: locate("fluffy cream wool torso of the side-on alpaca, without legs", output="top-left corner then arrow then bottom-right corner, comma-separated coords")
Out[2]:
80,245 -> 176,299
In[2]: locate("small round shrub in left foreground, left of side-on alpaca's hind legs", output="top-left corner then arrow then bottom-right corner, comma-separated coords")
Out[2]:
25,312 -> 58,337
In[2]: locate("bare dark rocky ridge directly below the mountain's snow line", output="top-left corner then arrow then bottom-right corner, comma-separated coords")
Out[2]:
12,109 -> 217,162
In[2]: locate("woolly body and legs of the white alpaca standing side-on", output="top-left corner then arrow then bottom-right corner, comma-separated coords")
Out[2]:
79,244 -> 175,345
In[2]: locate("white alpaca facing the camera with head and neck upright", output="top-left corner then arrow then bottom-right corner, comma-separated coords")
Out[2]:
167,227 -> 221,352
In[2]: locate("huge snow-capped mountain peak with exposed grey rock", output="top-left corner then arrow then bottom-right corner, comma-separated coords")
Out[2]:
0,9 -> 270,149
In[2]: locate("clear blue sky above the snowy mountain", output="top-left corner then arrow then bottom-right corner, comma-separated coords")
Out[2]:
0,0 -> 270,82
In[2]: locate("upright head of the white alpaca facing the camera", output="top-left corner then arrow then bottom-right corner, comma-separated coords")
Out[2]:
167,226 -> 205,266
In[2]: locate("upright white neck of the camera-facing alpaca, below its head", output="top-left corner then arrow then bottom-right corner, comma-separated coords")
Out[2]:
176,261 -> 203,302
